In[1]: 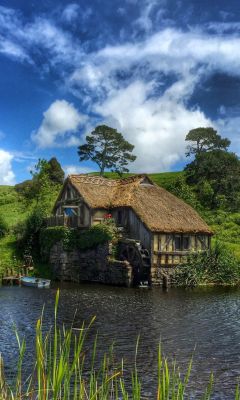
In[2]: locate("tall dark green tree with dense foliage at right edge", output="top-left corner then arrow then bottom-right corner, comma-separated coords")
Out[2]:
185,128 -> 240,211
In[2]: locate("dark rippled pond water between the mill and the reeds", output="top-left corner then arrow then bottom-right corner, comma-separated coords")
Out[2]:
0,284 -> 240,399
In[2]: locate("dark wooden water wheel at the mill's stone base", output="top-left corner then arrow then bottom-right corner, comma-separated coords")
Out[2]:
119,241 -> 150,286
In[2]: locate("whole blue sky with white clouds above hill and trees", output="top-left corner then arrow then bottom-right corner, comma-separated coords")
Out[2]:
0,0 -> 240,184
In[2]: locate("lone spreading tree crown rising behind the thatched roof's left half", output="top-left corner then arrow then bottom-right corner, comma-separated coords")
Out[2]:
78,125 -> 136,176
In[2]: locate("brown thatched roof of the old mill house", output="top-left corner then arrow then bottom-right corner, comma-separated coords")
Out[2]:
58,175 -> 212,234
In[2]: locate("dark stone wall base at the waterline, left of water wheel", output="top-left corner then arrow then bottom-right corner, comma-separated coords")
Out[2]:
49,243 -> 132,286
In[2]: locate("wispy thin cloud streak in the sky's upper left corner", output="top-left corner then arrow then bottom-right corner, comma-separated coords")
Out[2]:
0,6 -> 83,67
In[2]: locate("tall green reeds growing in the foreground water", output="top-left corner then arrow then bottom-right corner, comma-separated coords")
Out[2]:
0,292 -> 240,400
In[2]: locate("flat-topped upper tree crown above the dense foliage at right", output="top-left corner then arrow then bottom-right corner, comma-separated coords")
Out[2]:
185,127 -> 231,157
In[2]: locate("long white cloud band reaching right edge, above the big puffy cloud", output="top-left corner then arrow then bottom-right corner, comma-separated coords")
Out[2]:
69,29 -> 240,94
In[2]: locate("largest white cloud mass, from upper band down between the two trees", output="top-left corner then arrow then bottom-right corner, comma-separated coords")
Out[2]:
69,29 -> 240,172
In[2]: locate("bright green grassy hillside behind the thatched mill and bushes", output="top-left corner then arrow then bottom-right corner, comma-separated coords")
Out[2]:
0,172 -> 240,272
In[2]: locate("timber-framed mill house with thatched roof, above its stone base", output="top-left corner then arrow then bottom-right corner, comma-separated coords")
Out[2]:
51,175 -> 212,266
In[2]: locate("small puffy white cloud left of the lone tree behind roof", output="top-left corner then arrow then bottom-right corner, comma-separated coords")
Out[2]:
32,100 -> 86,148
